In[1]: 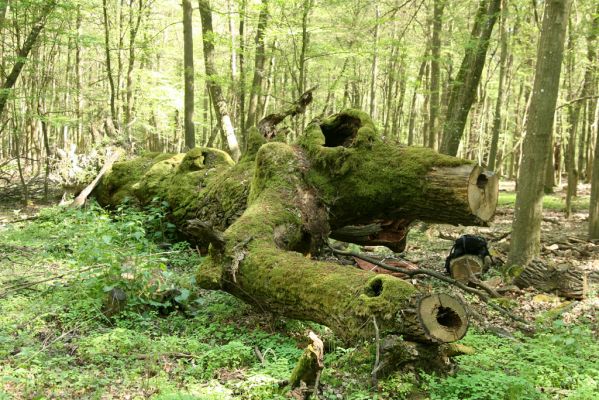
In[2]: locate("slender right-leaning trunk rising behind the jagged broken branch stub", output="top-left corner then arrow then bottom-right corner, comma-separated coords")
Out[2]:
245,0 -> 269,128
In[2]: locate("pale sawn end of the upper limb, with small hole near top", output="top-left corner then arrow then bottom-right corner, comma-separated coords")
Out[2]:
468,166 -> 499,222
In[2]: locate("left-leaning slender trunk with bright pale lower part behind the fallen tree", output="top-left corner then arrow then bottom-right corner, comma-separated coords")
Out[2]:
198,0 -> 241,161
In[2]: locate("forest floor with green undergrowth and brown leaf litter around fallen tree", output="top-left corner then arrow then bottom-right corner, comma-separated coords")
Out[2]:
0,182 -> 599,400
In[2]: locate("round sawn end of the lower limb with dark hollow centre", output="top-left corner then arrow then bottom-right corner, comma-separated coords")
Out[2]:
417,293 -> 468,343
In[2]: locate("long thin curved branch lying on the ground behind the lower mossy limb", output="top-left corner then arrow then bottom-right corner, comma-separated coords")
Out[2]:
331,248 -> 531,330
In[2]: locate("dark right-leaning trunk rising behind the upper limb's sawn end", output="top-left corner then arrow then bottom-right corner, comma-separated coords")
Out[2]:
440,0 -> 501,156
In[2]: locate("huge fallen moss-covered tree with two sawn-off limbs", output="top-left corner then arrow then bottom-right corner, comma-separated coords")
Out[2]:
97,110 -> 498,343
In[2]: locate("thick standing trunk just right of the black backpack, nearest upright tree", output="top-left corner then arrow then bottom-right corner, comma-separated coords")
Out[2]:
507,0 -> 570,265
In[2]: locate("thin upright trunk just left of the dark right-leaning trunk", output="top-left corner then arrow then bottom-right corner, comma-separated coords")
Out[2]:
428,0 -> 445,149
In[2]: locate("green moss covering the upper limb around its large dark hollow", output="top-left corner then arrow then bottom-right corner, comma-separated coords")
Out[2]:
299,110 -> 472,225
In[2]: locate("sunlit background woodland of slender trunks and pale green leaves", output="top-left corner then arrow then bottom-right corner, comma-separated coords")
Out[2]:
0,0 -> 599,241
